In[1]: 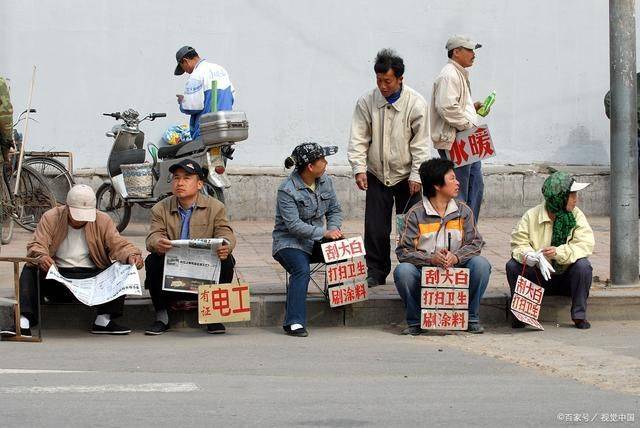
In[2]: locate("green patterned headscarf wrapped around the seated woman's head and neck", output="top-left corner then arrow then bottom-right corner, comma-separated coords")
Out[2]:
542,171 -> 576,247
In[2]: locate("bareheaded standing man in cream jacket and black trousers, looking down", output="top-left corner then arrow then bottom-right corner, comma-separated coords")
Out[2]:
347,49 -> 431,287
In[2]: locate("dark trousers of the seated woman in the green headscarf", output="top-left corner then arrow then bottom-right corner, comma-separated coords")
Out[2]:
506,258 -> 593,320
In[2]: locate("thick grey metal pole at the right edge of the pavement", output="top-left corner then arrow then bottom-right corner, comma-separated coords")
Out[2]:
609,0 -> 638,286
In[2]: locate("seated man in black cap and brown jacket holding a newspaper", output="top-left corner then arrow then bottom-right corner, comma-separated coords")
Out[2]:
145,159 -> 236,335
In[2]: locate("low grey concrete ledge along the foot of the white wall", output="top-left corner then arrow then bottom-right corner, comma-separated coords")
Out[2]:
76,165 -> 609,222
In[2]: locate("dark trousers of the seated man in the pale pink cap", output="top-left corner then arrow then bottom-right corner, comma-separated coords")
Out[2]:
20,265 -> 125,326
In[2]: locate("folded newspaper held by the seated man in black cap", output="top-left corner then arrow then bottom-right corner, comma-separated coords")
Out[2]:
162,238 -> 226,294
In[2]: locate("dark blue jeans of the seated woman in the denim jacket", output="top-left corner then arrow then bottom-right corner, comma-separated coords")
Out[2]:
273,248 -> 311,326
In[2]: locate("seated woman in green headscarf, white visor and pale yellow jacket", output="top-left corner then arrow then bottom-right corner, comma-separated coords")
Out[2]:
506,171 -> 594,329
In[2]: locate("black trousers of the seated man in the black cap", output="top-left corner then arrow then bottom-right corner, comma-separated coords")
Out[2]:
144,253 -> 236,311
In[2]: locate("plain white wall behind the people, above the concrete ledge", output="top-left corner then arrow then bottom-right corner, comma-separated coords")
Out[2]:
0,0 -> 640,167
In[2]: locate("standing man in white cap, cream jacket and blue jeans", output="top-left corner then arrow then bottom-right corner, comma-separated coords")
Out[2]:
429,36 -> 484,222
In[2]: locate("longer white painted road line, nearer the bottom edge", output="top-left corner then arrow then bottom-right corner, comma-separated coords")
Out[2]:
0,383 -> 200,394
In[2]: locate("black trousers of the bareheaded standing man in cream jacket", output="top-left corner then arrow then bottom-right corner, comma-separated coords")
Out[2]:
364,172 -> 421,284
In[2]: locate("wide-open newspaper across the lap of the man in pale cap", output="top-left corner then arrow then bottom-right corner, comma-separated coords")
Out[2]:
47,262 -> 142,306
